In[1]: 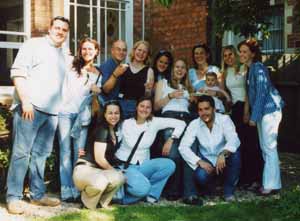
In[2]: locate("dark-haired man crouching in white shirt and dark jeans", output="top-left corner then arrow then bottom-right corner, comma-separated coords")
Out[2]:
179,95 -> 241,204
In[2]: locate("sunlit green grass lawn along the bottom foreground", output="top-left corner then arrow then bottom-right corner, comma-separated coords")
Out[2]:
33,200 -> 300,221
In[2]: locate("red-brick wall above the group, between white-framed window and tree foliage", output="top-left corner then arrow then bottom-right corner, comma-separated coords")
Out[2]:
134,0 -> 207,64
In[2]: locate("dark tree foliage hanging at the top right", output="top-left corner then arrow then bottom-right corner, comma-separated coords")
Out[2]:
157,0 -> 271,37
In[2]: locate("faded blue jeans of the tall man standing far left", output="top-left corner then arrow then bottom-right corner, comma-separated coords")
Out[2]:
6,105 -> 58,202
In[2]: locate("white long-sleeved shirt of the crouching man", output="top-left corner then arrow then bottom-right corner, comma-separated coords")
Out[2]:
178,113 -> 240,170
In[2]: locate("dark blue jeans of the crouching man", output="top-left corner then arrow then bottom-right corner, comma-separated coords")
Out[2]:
194,149 -> 241,197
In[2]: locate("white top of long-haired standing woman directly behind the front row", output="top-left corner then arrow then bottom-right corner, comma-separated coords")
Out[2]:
162,79 -> 189,113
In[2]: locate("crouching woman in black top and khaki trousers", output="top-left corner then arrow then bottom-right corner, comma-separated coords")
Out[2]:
73,101 -> 125,209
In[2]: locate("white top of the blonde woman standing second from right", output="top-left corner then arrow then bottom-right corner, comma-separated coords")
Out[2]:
225,68 -> 246,104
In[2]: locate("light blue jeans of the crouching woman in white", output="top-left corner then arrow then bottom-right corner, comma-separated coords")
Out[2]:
122,158 -> 175,204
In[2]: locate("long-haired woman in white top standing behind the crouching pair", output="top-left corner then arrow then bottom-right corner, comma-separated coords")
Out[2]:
154,59 -> 193,200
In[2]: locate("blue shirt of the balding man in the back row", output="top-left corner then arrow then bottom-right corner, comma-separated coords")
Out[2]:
99,58 -> 120,101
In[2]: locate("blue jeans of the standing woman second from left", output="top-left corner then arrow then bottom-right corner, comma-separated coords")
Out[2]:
58,113 -> 88,200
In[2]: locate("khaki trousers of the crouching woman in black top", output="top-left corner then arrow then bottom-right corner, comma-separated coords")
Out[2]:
73,165 -> 125,209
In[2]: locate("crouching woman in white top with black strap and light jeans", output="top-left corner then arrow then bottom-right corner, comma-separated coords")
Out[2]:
115,97 -> 186,204
